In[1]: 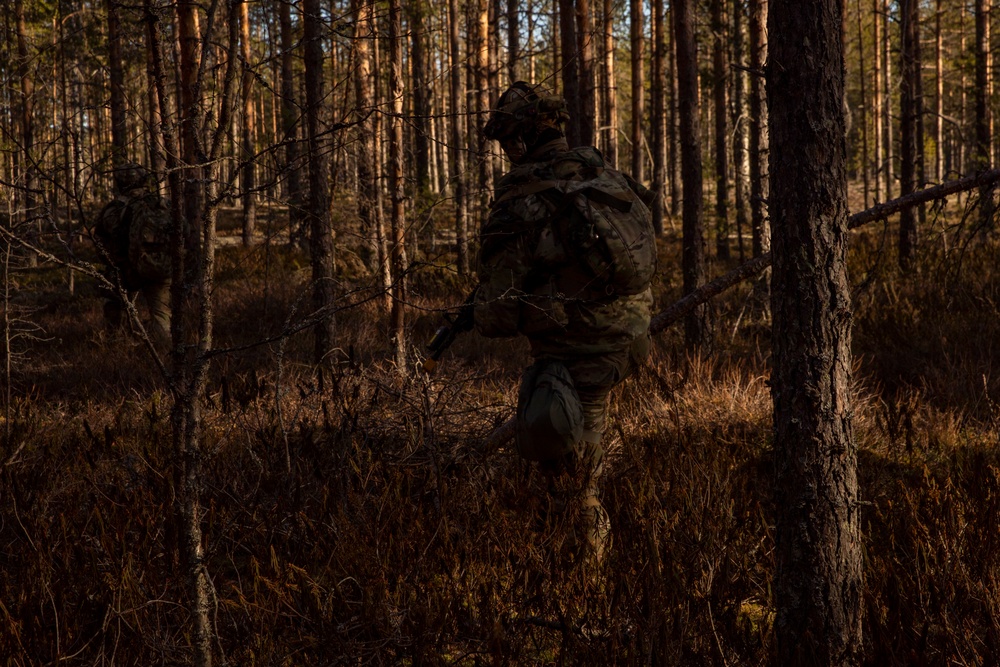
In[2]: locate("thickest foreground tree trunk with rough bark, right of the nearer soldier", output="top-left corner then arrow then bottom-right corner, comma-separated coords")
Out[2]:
768,0 -> 862,667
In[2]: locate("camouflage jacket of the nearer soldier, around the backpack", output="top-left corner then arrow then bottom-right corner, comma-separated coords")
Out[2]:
475,140 -> 653,357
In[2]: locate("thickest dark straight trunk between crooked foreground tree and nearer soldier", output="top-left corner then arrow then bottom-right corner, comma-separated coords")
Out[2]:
302,0 -> 334,366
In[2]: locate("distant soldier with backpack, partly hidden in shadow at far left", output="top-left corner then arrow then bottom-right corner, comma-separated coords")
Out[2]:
94,162 -> 170,342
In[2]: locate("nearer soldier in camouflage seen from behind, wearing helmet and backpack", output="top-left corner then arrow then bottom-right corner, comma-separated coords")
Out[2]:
475,81 -> 655,563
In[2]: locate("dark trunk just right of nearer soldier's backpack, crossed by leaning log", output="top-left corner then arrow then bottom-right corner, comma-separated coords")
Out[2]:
673,0 -> 708,348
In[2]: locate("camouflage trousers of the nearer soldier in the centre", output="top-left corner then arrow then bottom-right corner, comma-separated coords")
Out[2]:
539,336 -> 649,562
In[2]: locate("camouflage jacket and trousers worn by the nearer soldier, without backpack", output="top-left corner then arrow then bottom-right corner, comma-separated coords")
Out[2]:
475,82 -> 653,559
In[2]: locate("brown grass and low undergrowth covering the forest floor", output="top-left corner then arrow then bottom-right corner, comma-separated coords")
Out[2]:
0,196 -> 1000,667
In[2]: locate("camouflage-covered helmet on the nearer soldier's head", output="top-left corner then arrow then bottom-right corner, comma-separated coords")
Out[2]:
483,81 -> 569,143
